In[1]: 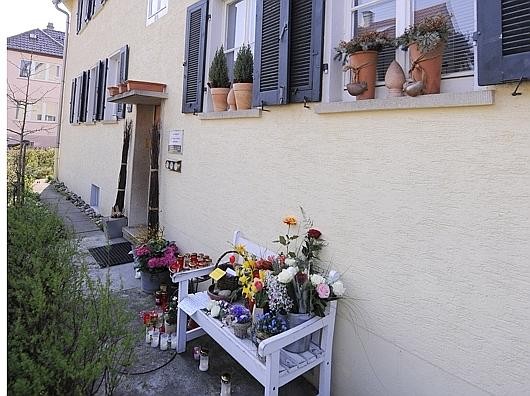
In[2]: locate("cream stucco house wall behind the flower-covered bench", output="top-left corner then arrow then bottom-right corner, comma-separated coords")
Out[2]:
59,0 -> 530,396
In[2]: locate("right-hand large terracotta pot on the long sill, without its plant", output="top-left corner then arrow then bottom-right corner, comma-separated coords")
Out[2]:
409,43 -> 445,94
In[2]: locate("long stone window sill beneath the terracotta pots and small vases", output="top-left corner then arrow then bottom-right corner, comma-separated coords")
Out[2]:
315,90 -> 495,114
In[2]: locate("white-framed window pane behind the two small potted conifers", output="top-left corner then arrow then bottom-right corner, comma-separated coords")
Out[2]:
224,0 -> 256,80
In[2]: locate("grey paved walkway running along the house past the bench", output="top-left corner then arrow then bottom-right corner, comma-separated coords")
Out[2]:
34,182 -> 317,396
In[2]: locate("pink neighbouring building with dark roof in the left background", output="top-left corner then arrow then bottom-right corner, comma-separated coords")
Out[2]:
7,23 -> 64,147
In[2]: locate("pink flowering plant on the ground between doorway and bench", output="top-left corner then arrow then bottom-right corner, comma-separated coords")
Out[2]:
134,236 -> 178,273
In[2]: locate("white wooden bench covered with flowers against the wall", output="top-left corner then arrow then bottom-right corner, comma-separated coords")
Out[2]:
172,231 -> 337,396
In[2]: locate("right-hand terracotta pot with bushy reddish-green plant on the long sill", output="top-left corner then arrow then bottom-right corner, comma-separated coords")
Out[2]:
397,14 -> 451,94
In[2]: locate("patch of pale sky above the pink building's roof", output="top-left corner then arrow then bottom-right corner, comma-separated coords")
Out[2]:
1,0 -> 66,37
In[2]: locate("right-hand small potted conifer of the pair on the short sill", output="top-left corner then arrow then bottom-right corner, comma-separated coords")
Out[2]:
233,45 -> 254,110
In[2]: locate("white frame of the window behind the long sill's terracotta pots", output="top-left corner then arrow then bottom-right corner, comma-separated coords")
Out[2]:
330,0 -> 474,102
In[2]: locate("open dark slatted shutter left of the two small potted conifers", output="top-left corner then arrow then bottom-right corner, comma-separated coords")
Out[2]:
182,0 -> 208,113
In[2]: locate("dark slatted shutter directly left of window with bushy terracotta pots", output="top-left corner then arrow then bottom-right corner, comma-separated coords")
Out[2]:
289,0 -> 324,103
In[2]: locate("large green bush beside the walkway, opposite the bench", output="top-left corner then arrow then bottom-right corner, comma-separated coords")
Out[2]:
7,199 -> 133,395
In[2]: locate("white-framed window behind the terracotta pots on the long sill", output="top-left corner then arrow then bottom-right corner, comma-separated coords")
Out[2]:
338,0 -> 475,100
